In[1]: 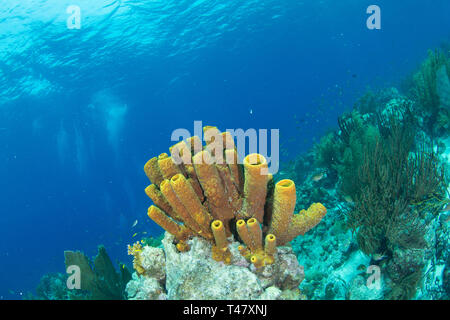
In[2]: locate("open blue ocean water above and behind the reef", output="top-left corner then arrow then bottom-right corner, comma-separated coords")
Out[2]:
0,0 -> 450,299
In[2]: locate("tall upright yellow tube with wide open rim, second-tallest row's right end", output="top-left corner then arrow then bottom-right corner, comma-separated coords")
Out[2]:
241,153 -> 269,223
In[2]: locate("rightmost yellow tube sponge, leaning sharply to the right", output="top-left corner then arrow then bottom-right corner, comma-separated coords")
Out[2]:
279,203 -> 327,245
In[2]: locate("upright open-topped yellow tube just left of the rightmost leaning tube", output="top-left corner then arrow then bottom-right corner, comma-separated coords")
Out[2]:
269,179 -> 297,237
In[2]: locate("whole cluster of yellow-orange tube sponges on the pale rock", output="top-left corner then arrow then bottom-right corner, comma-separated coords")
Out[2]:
144,126 -> 327,268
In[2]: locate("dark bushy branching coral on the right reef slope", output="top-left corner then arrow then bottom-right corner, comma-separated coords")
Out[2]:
347,114 -> 447,299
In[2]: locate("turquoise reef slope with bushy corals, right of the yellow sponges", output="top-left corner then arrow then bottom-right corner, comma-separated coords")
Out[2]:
286,83 -> 450,299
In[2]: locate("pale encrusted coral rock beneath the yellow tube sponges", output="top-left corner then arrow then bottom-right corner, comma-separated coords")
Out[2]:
126,232 -> 304,300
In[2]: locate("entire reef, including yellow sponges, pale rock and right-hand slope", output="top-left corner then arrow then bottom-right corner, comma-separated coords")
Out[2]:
27,43 -> 450,300
